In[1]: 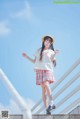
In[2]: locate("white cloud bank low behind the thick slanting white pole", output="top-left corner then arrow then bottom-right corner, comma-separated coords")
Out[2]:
0,99 -> 35,114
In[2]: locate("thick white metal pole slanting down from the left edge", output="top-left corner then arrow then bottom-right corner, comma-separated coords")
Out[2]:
0,68 -> 32,119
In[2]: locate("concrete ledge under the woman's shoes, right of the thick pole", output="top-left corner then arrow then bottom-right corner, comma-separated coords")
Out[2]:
33,105 -> 80,119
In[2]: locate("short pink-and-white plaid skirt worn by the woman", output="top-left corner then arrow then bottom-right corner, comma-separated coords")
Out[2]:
35,70 -> 55,85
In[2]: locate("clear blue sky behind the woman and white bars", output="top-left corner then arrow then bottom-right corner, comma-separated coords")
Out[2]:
0,0 -> 80,114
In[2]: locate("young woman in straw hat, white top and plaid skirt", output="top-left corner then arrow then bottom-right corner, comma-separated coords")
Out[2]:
23,36 -> 58,114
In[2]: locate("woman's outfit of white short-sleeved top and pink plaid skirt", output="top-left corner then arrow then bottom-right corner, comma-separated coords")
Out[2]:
34,49 -> 55,85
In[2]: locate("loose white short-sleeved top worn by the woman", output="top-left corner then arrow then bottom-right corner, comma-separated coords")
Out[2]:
34,49 -> 55,72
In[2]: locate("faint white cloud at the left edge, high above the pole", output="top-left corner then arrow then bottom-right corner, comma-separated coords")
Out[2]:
0,21 -> 11,36
